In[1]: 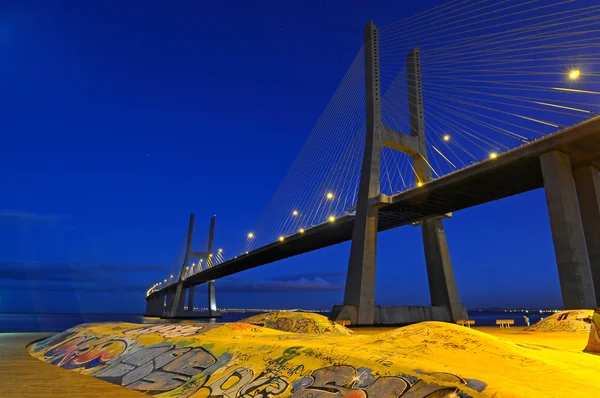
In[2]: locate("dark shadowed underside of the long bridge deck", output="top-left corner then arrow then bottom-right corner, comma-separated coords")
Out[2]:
153,118 -> 600,294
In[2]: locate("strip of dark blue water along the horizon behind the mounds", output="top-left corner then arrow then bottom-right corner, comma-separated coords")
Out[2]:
0,311 -> 550,332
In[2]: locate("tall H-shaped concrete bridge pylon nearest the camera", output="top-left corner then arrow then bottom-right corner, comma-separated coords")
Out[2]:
332,21 -> 466,325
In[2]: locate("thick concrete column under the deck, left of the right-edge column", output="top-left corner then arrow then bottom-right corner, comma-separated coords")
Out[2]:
540,150 -> 596,309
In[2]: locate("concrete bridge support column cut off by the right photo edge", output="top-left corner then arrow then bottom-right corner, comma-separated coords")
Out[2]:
573,166 -> 600,307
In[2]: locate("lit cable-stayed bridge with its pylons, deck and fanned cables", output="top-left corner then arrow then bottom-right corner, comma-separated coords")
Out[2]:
146,0 -> 600,324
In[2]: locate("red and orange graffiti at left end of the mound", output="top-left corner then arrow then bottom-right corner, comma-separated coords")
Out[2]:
44,335 -> 127,369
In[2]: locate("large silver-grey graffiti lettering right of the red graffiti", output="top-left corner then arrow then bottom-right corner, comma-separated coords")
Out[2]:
94,345 -> 217,393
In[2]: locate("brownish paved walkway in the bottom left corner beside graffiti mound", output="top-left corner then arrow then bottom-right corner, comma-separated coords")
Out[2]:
0,333 -> 148,398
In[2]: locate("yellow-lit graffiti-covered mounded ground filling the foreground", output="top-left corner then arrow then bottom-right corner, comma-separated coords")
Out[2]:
29,313 -> 600,398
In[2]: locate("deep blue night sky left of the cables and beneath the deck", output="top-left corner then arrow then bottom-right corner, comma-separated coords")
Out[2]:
0,0 -> 561,312
